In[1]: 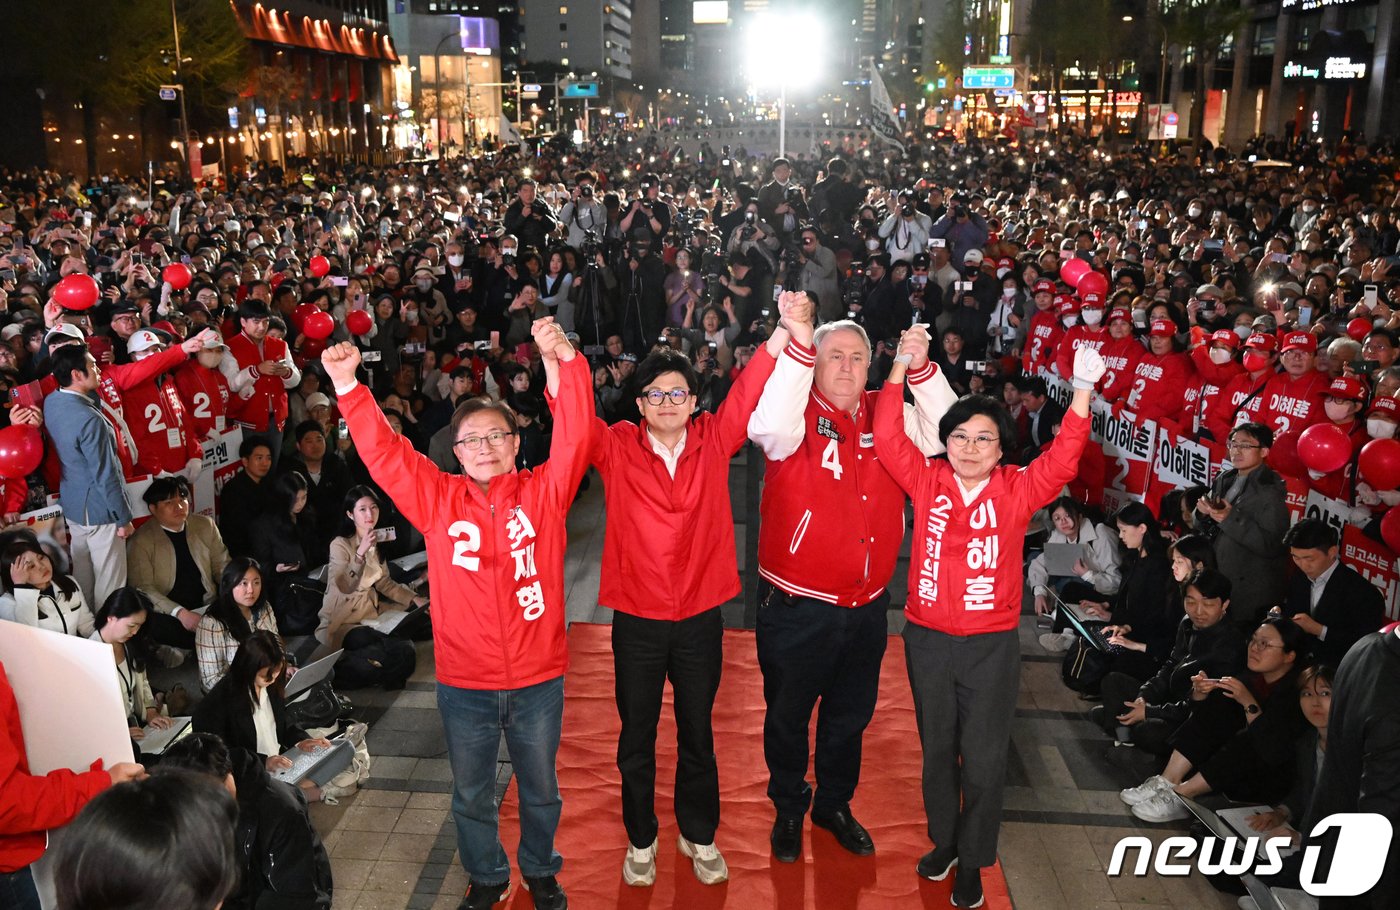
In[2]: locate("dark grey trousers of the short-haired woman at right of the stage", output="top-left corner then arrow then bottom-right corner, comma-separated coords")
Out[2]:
904,623 -> 1021,869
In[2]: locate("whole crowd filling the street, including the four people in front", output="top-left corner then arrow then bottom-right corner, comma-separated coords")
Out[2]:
0,126 -> 1400,907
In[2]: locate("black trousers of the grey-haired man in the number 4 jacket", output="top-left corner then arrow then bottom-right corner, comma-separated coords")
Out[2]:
756,585 -> 889,816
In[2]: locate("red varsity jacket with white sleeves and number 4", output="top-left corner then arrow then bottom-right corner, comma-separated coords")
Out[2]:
749,342 -> 958,606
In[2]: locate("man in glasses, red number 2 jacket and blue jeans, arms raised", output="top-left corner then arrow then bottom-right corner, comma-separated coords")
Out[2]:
321,319 -> 594,909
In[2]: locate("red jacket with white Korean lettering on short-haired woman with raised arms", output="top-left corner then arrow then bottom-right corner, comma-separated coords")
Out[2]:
875,392 -> 1089,636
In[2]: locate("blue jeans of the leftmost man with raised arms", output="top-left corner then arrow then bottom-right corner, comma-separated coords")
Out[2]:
437,676 -> 564,885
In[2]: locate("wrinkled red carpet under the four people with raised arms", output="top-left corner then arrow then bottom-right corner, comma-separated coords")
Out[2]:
501,623 -> 1011,910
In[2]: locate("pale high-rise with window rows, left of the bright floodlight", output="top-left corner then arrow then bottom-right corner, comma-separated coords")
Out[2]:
521,0 -> 635,80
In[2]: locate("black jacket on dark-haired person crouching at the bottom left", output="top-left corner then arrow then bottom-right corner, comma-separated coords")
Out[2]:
224,749 -> 332,910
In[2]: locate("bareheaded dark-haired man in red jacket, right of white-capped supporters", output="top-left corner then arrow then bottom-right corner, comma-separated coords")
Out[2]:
220,297 -> 301,470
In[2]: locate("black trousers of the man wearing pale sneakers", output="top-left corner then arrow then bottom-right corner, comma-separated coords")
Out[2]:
612,606 -> 724,847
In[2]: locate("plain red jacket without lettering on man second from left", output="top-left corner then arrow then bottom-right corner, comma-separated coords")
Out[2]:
588,347 -> 777,620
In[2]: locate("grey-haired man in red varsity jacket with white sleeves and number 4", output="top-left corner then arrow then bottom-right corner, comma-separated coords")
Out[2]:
749,294 -> 956,862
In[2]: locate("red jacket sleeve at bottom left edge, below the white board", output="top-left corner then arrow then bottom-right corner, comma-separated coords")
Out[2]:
0,664 -> 112,874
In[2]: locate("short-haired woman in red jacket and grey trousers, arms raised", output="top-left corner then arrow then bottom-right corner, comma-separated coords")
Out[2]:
875,333 -> 1105,907
